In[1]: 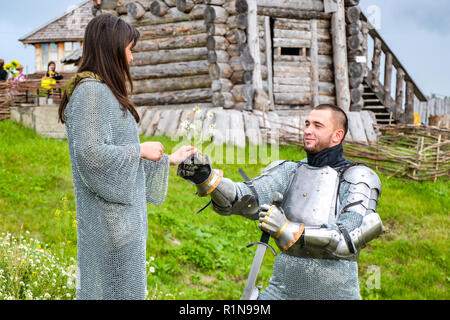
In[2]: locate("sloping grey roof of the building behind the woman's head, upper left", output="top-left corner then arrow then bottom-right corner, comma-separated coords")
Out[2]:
19,0 -> 93,44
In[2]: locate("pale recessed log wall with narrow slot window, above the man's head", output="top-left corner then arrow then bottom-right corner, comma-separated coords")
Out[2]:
273,18 -> 336,109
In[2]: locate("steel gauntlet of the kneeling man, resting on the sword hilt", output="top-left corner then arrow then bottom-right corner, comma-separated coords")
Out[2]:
259,204 -> 305,251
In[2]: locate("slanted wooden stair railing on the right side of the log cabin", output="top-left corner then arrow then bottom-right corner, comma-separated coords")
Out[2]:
360,12 -> 428,124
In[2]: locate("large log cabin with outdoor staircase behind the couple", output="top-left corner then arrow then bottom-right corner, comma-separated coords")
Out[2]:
19,0 -> 427,146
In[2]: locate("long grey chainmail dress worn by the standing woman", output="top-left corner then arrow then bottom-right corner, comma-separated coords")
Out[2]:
64,79 -> 169,300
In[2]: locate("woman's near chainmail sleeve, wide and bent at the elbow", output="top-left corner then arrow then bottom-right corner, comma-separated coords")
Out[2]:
69,81 -> 140,204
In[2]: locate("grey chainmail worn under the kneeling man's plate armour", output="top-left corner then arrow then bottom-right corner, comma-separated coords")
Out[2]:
236,159 -> 362,300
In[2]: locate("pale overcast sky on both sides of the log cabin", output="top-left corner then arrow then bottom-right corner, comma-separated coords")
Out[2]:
0,0 -> 450,96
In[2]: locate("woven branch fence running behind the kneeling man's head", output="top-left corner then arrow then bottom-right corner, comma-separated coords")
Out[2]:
264,119 -> 450,181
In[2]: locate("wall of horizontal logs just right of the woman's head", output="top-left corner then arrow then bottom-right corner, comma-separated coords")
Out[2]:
115,0 -> 215,106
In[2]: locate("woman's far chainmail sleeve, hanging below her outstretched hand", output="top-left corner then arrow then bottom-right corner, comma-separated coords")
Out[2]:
142,154 -> 169,206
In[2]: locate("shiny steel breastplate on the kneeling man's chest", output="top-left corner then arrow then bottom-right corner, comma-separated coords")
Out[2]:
282,165 -> 339,226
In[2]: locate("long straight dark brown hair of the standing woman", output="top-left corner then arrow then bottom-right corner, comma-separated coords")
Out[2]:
59,14 -> 140,123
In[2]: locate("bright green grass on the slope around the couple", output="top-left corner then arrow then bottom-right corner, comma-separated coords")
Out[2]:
0,120 -> 450,299
